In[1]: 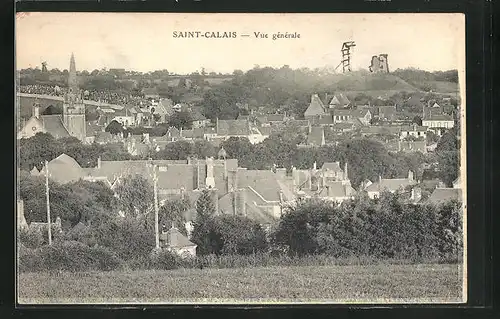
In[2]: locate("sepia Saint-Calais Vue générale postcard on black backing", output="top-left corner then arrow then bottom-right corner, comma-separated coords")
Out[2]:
13,12 -> 467,305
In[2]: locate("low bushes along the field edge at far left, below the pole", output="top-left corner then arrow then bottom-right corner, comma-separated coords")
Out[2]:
19,241 -> 123,271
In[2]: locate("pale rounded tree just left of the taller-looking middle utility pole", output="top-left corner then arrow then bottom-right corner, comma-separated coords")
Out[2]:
114,175 -> 154,217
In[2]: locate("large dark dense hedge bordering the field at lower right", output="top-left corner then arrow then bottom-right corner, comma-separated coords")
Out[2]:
273,193 -> 462,262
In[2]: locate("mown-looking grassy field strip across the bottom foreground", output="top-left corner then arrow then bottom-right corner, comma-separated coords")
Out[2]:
18,265 -> 462,304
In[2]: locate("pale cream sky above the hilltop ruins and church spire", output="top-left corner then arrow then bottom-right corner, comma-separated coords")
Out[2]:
16,13 -> 465,74
